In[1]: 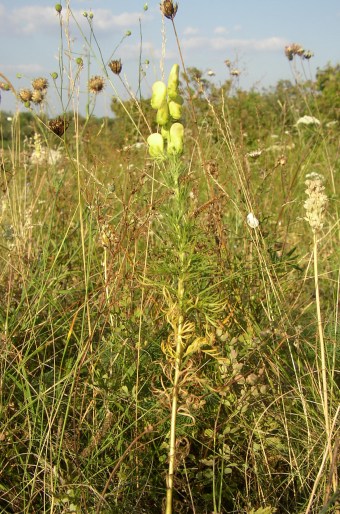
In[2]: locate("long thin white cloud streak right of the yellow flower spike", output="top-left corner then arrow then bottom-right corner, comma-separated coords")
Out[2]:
182,36 -> 287,51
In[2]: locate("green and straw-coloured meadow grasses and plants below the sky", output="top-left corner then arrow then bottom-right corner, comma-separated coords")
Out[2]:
0,0 -> 340,514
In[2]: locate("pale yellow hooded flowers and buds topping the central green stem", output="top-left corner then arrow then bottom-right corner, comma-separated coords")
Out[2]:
148,64 -> 184,158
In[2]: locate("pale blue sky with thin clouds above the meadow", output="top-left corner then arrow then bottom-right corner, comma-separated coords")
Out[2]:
0,0 -> 340,116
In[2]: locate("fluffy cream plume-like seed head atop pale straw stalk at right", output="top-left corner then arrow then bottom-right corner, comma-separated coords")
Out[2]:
304,173 -> 328,233
